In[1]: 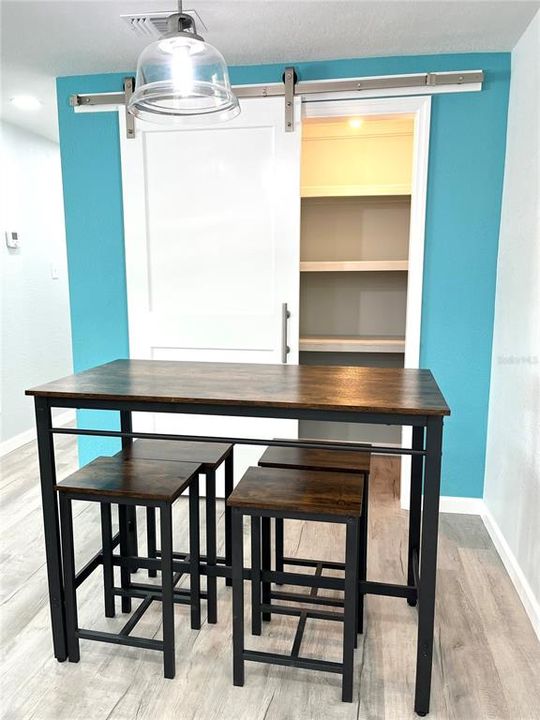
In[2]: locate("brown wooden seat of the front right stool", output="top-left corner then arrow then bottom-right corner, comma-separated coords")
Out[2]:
227,467 -> 364,517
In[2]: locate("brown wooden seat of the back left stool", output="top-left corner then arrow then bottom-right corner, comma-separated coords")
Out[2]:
118,439 -> 233,472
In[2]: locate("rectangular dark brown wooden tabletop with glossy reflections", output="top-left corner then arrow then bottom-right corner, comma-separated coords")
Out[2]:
26,360 -> 450,415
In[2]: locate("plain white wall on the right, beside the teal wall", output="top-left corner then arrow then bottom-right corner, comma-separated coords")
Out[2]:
484,13 -> 540,637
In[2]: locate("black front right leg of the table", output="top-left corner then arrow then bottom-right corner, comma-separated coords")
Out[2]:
414,417 -> 443,715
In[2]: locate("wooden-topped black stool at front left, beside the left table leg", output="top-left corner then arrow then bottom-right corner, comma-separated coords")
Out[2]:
56,456 -> 201,678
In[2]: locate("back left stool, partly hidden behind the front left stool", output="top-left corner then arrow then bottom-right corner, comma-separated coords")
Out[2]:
118,439 -> 234,624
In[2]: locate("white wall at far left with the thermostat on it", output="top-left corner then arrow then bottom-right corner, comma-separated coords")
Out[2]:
0,123 -> 72,452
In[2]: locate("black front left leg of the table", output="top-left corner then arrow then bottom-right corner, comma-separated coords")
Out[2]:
35,397 -> 67,662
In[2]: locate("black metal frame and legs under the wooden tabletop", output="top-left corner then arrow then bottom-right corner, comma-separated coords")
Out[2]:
35,395 -> 443,715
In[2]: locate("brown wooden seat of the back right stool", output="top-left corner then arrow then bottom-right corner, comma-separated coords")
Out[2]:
259,445 -> 372,474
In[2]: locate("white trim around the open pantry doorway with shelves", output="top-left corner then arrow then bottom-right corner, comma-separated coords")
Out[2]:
302,95 -> 431,508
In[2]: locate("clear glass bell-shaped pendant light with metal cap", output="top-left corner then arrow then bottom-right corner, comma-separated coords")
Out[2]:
128,1 -> 240,125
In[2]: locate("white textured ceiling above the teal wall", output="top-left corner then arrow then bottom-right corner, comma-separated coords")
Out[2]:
0,0 -> 540,138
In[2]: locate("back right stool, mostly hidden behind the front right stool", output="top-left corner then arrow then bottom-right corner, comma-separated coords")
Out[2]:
259,445 -> 372,633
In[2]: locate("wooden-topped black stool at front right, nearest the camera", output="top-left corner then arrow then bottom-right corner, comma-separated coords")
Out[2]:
227,467 -> 364,702
